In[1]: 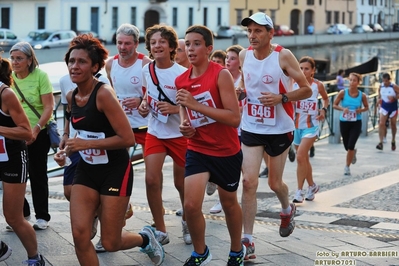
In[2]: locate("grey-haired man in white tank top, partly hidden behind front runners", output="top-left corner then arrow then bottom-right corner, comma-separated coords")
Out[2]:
105,23 -> 151,160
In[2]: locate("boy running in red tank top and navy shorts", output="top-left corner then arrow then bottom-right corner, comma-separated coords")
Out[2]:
175,25 -> 246,266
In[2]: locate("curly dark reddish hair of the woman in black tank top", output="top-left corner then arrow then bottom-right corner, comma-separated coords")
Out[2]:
64,34 -> 108,75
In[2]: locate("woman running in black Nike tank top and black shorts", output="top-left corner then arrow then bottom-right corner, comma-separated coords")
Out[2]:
54,34 -> 165,266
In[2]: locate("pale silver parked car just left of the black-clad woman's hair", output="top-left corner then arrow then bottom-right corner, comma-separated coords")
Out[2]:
28,30 -> 76,49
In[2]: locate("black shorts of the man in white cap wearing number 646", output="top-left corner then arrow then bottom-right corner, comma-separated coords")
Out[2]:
241,130 -> 294,157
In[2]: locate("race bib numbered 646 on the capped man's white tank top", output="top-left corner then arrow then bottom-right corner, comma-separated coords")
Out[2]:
247,101 -> 276,126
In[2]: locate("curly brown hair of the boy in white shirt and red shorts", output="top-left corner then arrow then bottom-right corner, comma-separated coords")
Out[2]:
145,24 -> 178,61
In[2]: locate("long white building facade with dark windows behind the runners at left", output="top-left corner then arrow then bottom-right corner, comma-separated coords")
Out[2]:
0,0 -> 230,41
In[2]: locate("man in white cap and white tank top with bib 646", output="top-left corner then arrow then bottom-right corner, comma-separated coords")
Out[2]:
239,12 -> 312,259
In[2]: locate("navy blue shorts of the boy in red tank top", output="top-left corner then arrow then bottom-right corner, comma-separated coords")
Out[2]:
184,150 -> 242,192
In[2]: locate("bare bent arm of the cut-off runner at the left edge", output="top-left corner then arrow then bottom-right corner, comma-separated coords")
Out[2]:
0,88 -> 32,141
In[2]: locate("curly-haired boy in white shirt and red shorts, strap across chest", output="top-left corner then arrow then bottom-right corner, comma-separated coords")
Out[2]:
139,25 -> 191,245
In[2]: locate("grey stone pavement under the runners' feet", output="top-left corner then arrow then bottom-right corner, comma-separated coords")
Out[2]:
0,130 -> 399,266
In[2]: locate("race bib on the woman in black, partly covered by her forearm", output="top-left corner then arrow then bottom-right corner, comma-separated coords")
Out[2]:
77,130 -> 108,164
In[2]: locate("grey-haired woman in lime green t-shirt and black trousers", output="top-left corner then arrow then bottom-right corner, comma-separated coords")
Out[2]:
10,42 -> 54,230
